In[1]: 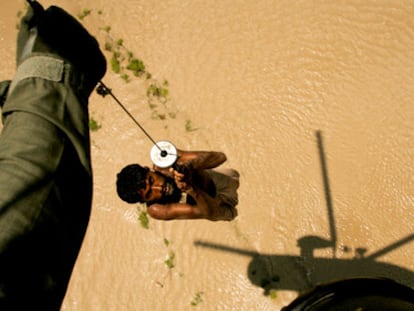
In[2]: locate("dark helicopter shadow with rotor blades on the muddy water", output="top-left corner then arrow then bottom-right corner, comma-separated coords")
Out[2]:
194,131 -> 414,295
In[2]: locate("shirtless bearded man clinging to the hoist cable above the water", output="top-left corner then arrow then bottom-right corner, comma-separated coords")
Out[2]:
116,150 -> 239,221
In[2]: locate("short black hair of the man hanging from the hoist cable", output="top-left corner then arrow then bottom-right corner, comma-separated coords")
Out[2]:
116,164 -> 149,203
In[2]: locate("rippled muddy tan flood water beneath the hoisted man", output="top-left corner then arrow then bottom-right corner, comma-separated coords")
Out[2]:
0,0 -> 414,311
